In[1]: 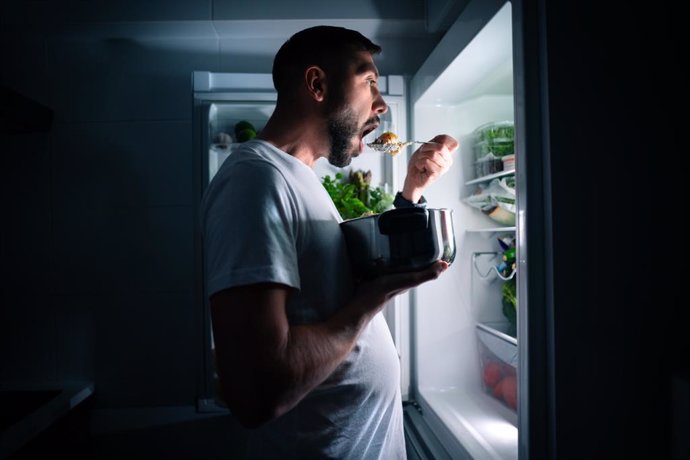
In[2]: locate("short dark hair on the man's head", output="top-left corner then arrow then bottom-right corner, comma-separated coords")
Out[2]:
273,26 -> 381,95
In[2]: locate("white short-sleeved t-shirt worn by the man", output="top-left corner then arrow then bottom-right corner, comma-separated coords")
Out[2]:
202,140 -> 405,460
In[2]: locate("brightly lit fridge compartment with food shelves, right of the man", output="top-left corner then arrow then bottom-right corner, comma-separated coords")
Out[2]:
398,2 -> 520,460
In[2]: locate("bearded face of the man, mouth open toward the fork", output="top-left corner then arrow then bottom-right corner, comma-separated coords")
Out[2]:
326,51 -> 388,167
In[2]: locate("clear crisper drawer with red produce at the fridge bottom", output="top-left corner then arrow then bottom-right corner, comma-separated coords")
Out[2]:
477,323 -> 518,411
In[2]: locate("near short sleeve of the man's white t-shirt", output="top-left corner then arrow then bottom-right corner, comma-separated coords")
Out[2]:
202,161 -> 300,297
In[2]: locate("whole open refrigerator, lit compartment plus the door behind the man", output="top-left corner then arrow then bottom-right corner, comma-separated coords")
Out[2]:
192,0 -> 549,460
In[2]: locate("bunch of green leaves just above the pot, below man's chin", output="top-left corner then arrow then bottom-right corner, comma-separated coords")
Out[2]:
322,170 -> 394,220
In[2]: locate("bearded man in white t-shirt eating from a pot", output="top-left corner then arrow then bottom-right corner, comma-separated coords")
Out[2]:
202,26 -> 458,460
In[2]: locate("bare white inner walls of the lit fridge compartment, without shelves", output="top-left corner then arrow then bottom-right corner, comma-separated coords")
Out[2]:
410,3 -> 518,459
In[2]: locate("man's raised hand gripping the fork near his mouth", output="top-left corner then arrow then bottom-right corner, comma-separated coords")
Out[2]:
402,134 -> 459,203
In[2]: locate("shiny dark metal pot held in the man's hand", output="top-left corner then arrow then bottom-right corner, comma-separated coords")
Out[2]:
340,208 -> 456,279
